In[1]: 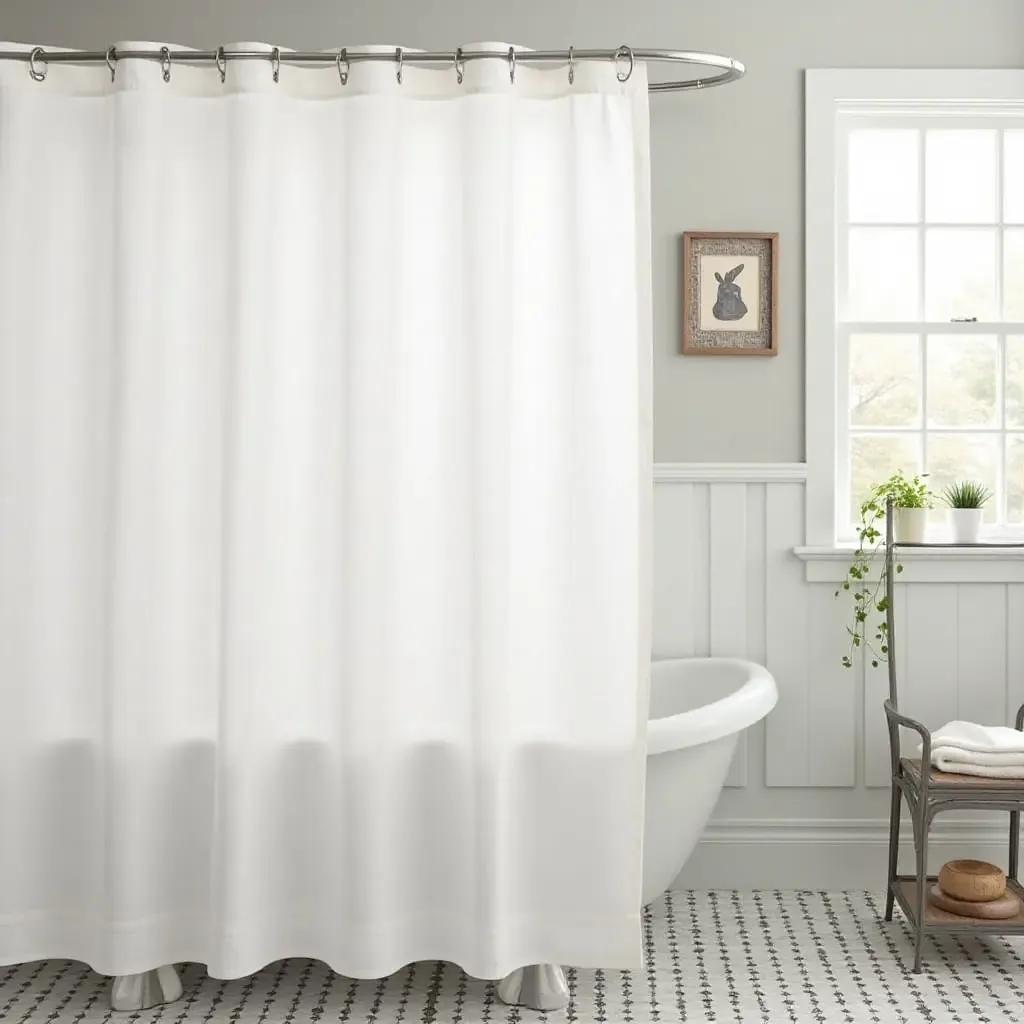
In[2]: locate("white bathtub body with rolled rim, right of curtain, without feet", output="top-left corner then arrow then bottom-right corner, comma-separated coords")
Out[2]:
643,657 -> 778,905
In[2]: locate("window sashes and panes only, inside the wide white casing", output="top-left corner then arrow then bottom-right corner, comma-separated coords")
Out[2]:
836,113 -> 1024,536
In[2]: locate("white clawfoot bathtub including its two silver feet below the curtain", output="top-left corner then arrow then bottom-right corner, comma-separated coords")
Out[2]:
112,657 -> 778,1011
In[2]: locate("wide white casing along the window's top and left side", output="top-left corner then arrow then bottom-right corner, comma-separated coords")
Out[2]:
804,69 -> 1024,552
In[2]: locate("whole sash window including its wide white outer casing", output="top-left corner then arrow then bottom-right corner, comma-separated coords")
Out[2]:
807,71 -> 1024,544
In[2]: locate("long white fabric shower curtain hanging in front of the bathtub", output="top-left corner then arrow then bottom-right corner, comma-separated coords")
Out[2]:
0,43 -> 650,978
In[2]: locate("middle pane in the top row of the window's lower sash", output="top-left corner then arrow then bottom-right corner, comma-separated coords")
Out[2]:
926,335 -> 998,427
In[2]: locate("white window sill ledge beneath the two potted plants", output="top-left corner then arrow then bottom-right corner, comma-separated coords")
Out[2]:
794,544 -> 1024,584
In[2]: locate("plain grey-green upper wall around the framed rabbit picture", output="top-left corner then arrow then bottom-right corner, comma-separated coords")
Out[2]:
8,0 -> 1024,462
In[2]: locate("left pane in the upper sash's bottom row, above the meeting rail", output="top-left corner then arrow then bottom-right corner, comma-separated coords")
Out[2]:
846,227 -> 921,321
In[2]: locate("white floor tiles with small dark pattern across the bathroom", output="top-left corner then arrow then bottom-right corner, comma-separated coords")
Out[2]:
0,892 -> 1024,1024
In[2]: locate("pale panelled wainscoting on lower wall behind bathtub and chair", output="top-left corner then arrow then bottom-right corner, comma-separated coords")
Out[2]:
653,463 -> 1024,888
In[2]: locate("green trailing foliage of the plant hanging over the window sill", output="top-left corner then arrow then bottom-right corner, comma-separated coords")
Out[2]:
836,470 -> 932,669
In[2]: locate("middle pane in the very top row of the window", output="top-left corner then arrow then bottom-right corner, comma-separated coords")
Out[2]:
925,128 -> 997,224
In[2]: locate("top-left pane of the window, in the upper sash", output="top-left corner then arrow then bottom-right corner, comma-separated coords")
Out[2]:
848,128 -> 921,224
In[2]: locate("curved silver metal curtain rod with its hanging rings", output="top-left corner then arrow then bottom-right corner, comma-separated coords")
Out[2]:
0,46 -> 745,92
